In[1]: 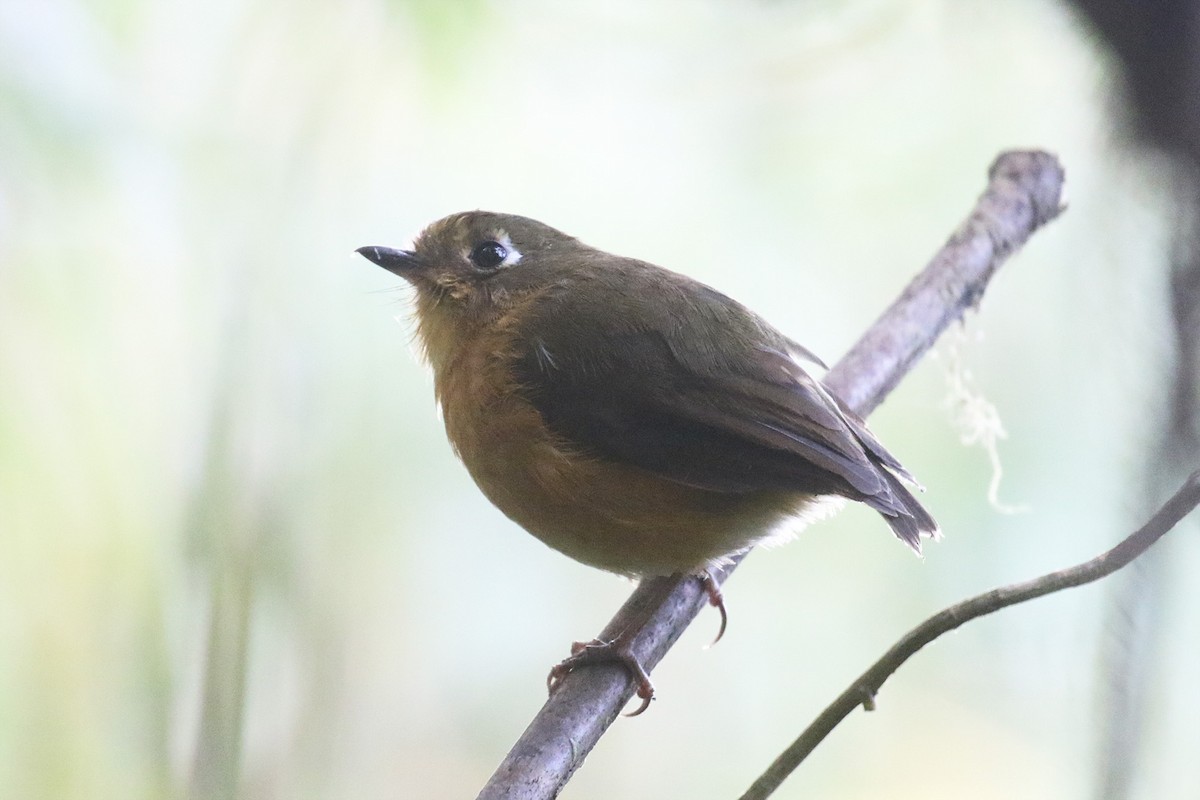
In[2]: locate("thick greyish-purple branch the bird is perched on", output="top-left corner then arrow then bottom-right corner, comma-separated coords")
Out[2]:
479,151 -> 1063,800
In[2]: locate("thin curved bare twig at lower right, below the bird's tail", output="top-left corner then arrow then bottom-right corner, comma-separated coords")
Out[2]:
740,470 -> 1200,800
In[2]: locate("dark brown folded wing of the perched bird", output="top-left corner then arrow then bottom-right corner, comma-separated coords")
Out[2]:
514,281 -> 936,547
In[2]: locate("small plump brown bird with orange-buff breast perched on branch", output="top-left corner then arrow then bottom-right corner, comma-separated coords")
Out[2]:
356,211 -> 940,714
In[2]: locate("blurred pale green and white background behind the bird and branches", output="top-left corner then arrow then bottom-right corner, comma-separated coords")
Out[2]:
0,0 -> 1200,800
